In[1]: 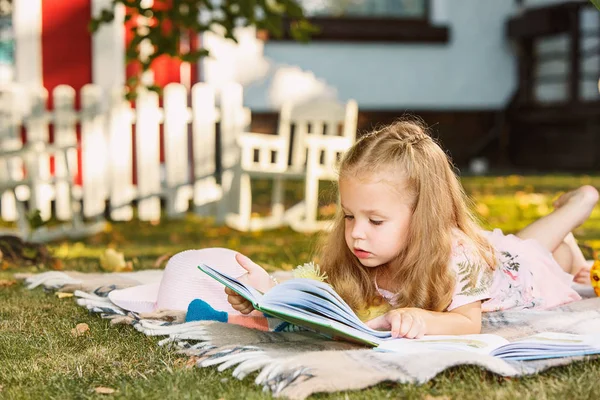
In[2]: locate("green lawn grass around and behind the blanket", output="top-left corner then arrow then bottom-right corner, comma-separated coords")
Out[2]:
0,176 -> 600,399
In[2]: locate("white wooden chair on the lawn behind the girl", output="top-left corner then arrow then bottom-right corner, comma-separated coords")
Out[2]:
225,95 -> 358,231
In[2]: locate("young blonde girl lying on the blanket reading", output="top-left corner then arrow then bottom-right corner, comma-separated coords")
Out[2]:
226,121 -> 598,338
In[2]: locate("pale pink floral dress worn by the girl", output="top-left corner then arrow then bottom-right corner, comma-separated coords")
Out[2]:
448,229 -> 581,312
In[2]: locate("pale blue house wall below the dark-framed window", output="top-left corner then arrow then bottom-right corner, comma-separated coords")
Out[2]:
234,0 -> 517,111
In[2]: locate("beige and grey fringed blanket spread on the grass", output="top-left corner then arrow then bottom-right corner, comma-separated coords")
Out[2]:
17,271 -> 600,399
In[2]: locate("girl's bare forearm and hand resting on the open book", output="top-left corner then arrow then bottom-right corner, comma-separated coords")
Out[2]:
367,301 -> 481,339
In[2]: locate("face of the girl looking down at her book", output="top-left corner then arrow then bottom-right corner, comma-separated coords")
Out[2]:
339,174 -> 412,267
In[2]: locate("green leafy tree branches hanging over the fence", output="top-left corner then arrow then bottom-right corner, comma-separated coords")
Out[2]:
89,0 -> 318,99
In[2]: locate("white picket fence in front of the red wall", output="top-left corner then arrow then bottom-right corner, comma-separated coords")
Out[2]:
0,83 -> 250,231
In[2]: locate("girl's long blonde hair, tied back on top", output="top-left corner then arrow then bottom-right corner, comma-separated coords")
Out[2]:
319,120 -> 495,311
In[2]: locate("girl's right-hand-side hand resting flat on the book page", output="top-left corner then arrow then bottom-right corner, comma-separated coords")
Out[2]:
367,308 -> 427,339
